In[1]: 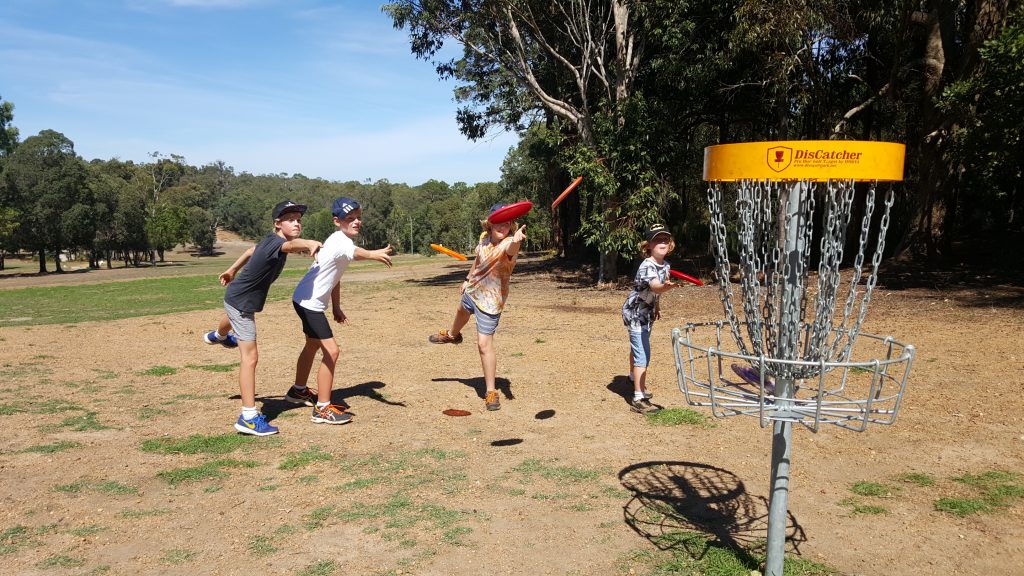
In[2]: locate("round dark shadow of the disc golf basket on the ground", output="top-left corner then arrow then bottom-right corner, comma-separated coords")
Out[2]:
618,461 -> 807,570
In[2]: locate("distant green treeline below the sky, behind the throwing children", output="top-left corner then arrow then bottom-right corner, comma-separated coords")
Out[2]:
0,130 -> 551,272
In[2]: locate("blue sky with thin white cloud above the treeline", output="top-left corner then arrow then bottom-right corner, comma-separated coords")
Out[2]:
0,0 -> 517,184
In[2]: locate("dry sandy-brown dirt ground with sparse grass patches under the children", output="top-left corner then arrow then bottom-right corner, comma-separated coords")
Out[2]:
0,241 -> 1024,575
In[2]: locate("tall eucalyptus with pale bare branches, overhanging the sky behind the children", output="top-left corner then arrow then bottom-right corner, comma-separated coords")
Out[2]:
384,0 -> 656,281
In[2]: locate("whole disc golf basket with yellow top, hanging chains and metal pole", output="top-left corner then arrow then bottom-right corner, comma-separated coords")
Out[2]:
672,140 -> 914,576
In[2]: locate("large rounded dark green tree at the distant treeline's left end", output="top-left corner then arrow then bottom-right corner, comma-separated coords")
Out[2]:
2,130 -> 92,274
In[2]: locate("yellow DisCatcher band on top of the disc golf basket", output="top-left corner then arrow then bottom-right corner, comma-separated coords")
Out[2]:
703,140 -> 906,181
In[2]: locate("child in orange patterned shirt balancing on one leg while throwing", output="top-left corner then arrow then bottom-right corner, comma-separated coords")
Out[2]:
429,203 -> 526,410
